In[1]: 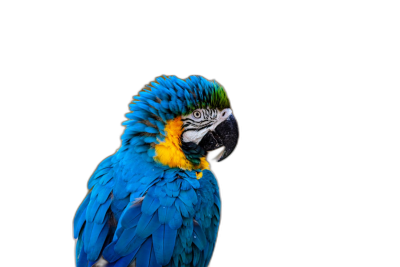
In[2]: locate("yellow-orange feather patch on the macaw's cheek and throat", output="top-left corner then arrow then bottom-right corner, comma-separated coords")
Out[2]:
154,117 -> 210,170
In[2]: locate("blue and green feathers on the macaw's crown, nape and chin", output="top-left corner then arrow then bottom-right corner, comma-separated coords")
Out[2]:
121,76 -> 230,166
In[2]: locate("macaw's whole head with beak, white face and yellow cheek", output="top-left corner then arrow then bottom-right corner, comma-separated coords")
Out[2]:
121,76 -> 239,170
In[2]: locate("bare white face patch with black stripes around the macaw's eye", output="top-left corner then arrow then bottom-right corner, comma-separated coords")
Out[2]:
182,108 -> 232,144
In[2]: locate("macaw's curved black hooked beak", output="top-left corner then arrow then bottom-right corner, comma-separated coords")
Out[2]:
199,114 -> 239,162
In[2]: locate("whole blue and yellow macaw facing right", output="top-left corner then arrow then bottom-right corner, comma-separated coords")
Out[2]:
73,76 -> 239,267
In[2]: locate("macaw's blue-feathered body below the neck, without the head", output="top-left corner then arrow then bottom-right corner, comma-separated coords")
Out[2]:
73,154 -> 221,267
